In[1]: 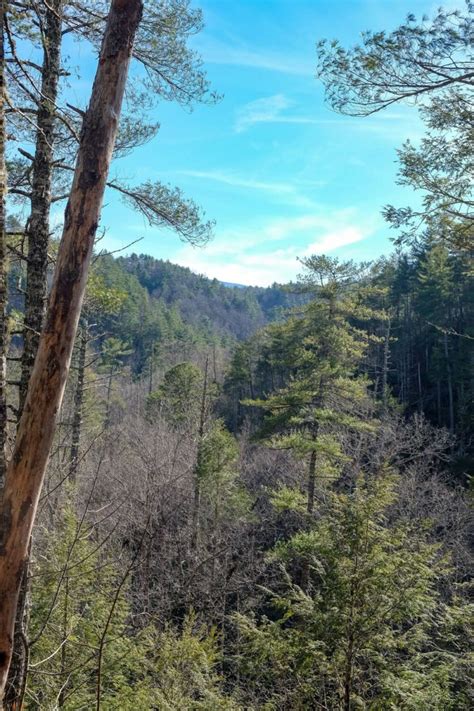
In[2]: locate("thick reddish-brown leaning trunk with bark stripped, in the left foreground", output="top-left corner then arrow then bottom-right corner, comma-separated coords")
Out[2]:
0,0 -> 142,698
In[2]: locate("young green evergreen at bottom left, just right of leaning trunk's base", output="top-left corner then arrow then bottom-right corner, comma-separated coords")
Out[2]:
26,505 -> 153,711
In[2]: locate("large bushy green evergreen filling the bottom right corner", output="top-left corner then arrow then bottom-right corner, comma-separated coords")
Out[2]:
236,475 -> 469,711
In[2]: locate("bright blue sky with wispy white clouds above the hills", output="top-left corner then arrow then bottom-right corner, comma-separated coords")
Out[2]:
65,0 -> 462,286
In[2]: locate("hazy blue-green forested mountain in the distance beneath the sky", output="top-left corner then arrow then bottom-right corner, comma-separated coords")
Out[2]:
86,254 -> 303,374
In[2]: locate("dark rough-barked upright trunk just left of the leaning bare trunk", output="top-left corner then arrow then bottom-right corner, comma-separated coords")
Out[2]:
18,0 -> 63,417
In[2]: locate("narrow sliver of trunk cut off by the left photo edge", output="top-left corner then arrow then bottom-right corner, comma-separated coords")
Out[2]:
0,0 -> 7,488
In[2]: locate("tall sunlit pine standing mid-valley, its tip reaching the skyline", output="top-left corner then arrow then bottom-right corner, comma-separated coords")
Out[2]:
241,256 -> 385,500
